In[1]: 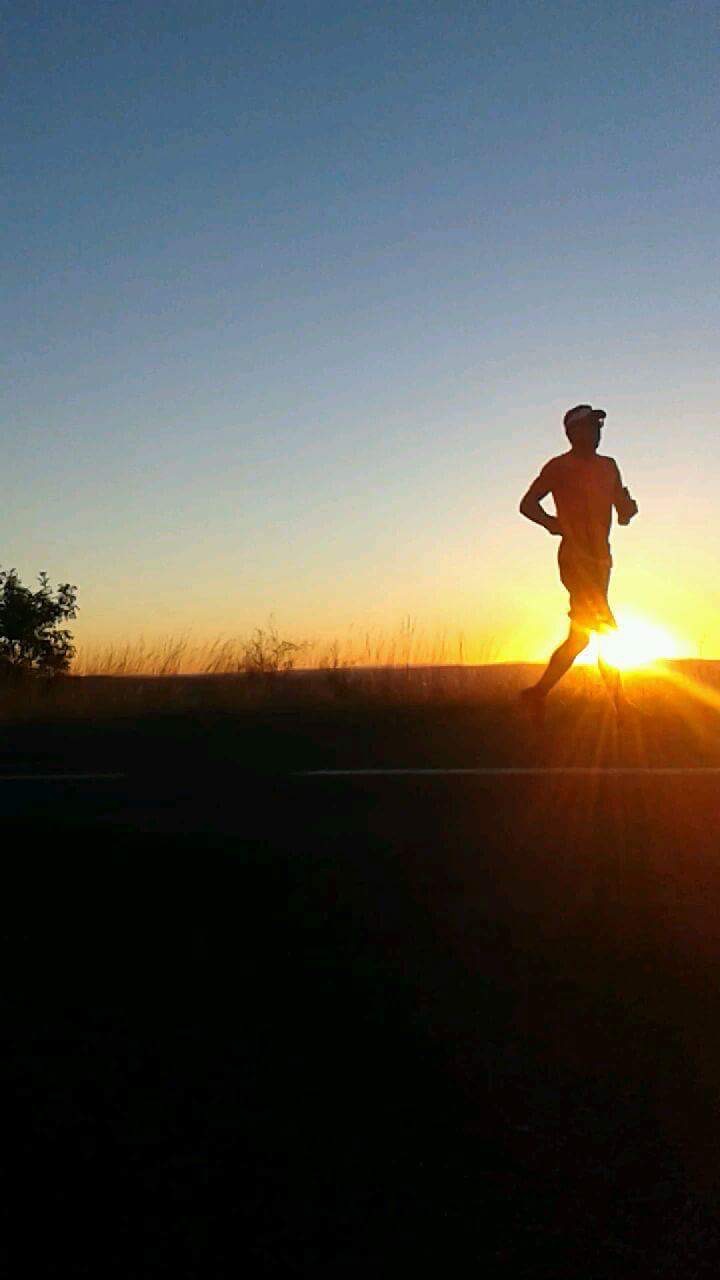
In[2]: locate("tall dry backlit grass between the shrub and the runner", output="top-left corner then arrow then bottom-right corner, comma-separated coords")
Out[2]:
58,617 -> 530,714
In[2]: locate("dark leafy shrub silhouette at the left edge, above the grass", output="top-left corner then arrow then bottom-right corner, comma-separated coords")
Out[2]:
0,568 -> 77,682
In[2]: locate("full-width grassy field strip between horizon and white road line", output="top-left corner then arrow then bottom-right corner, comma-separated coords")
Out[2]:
0,660 -> 720,774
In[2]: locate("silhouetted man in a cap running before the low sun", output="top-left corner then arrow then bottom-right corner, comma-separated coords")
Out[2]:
520,404 -> 638,723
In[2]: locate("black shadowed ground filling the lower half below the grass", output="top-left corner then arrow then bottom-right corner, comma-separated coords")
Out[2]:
0,705 -> 720,1280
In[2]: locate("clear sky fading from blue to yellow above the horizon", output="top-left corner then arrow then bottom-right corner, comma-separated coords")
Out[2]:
0,0 -> 720,658
